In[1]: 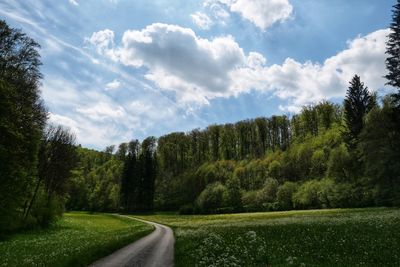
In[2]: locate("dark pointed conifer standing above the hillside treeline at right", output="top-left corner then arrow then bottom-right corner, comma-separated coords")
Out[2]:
344,75 -> 376,150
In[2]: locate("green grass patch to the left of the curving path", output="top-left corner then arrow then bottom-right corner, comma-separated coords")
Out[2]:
0,213 -> 153,266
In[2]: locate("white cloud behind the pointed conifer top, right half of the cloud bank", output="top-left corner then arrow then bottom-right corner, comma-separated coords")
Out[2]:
265,30 -> 389,107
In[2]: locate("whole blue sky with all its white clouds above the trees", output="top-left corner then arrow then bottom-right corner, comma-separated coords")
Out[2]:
0,0 -> 395,150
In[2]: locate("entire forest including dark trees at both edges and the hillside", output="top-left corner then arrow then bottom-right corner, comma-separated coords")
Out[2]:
0,1 -> 400,232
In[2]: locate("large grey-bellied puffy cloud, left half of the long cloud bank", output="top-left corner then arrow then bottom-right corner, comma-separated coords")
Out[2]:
106,23 -> 245,103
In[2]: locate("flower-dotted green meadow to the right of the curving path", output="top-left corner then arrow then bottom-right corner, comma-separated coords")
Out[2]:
135,208 -> 400,267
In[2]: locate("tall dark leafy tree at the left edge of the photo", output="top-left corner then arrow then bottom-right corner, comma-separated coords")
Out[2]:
0,20 -> 47,232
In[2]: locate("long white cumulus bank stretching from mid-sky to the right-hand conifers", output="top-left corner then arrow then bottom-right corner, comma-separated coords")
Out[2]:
90,23 -> 388,110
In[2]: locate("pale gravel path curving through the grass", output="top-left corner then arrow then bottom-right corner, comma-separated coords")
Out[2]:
90,215 -> 175,267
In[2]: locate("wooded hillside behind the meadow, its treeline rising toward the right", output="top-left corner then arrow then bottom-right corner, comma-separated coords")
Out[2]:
67,85 -> 400,213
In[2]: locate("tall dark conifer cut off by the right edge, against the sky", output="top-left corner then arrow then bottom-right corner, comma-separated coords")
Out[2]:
385,0 -> 400,92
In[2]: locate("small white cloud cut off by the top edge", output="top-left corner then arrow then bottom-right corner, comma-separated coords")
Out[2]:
203,0 -> 293,31
